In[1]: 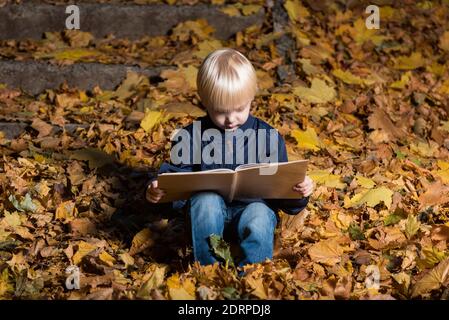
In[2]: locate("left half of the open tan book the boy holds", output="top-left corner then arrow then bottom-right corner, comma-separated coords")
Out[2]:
158,169 -> 235,203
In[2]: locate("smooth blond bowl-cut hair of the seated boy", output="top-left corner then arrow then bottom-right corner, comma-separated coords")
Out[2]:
196,48 -> 257,112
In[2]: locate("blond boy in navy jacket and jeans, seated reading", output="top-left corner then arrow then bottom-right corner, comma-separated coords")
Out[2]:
146,48 -> 313,266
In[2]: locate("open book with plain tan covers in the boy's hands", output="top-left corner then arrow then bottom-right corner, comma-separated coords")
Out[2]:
158,160 -> 309,202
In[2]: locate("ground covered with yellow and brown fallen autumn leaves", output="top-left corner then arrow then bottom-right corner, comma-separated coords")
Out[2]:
0,0 -> 449,299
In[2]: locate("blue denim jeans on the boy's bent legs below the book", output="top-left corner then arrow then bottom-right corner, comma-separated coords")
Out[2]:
188,192 -> 277,266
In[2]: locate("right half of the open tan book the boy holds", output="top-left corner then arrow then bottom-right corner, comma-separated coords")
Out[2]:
234,160 -> 308,199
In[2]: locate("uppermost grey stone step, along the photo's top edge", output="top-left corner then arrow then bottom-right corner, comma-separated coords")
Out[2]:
0,1 -> 265,40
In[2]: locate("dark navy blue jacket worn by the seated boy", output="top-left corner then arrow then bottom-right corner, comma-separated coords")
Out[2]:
150,115 -> 309,215
